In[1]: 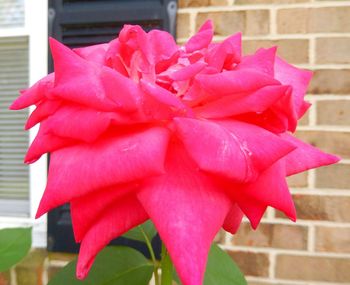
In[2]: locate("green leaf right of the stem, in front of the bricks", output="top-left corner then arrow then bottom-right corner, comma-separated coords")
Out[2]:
173,244 -> 247,285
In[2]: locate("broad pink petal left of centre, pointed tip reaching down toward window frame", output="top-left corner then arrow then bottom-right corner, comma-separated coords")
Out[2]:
37,128 -> 169,217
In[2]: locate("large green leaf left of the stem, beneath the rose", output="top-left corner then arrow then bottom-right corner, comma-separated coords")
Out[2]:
48,246 -> 153,285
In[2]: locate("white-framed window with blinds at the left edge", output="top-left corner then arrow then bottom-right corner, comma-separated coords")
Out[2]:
0,0 -> 47,247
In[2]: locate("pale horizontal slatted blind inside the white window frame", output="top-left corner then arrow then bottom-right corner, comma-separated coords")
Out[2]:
0,36 -> 29,216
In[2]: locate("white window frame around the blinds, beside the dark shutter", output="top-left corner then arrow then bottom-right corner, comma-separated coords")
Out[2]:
0,0 -> 48,247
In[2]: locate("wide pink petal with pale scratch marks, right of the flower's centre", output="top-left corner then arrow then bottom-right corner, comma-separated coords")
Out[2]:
174,118 -> 295,182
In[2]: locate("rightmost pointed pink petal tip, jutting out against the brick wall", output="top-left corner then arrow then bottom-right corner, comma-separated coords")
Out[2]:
280,133 -> 340,176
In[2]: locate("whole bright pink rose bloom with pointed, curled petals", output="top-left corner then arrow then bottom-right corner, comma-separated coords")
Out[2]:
11,21 -> 338,285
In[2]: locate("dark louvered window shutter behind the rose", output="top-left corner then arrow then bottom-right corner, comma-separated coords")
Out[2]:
47,0 -> 177,256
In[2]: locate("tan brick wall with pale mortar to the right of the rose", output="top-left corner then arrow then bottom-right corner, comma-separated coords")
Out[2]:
177,0 -> 350,285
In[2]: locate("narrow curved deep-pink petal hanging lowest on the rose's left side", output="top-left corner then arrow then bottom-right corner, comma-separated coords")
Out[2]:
76,196 -> 148,279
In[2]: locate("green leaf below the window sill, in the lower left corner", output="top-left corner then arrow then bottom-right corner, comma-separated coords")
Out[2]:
0,228 -> 32,272
